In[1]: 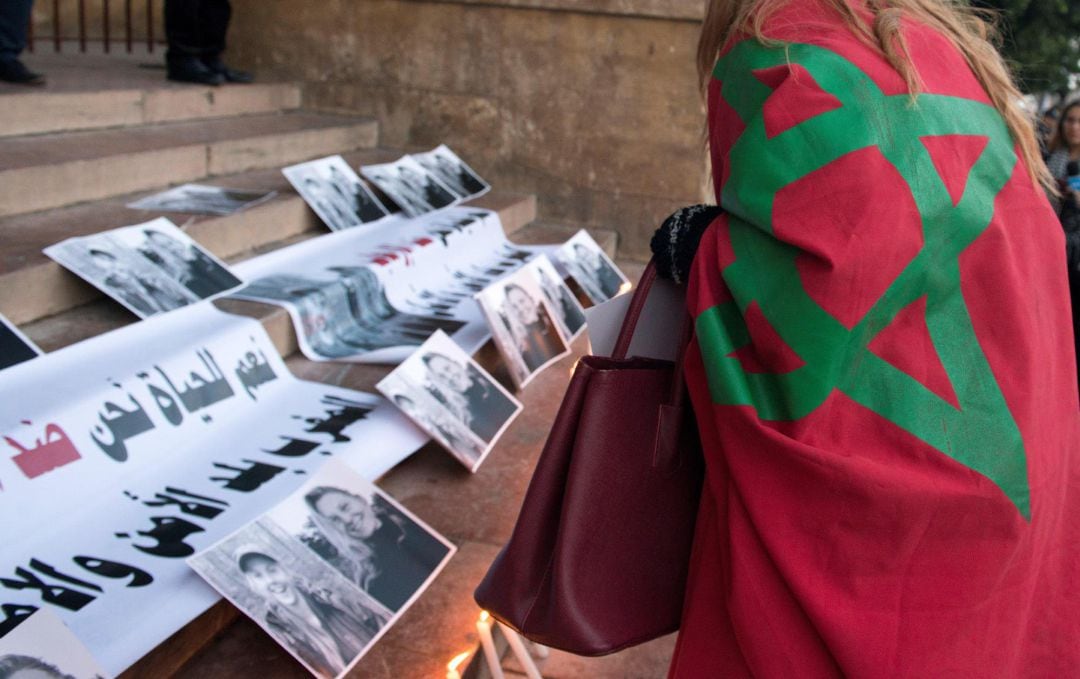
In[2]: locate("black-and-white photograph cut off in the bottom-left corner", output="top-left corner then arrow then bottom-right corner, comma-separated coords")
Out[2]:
0,607 -> 107,679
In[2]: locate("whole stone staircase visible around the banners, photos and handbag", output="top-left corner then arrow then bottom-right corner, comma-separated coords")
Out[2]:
0,55 -> 656,677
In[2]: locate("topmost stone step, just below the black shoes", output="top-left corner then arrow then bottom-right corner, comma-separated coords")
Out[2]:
0,45 -> 301,137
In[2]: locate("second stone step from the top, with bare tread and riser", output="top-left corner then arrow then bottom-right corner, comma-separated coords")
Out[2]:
0,112 -> 378,217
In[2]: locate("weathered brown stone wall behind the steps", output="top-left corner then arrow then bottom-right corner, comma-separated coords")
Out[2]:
230,0 -> 704,258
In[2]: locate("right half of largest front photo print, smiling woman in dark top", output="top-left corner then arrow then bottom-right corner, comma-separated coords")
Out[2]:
267,460 -> 455,614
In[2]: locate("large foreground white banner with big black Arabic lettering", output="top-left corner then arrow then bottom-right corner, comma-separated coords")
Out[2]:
0,302 -> 427,673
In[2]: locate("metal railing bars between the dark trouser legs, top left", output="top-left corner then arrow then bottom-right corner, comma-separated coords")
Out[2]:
28,0 -> 163,54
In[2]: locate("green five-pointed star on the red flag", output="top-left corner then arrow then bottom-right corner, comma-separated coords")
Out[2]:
697,40 -> 1030,519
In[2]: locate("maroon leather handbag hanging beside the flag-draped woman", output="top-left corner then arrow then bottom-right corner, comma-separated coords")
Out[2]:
474,257 -> 703,655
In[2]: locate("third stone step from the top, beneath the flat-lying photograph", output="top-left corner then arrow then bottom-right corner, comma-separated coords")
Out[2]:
0,149 -> 537,324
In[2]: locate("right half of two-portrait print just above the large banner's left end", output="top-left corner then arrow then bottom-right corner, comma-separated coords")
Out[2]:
111,217 -> 243,299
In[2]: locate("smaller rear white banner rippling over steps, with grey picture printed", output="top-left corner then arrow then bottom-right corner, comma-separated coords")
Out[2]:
233,207 -> 553,363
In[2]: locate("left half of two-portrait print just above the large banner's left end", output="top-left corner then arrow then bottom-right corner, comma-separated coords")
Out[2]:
44,232 -> 199,318
